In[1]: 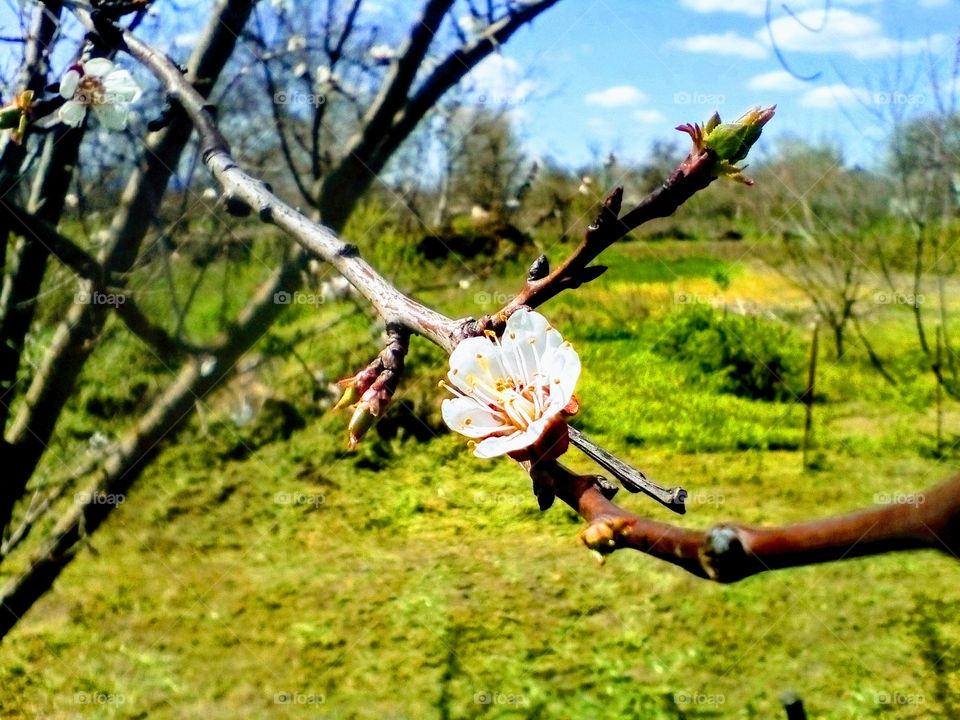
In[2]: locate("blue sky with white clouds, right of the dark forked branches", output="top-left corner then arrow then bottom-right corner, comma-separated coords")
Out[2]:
478,0 -> 960,165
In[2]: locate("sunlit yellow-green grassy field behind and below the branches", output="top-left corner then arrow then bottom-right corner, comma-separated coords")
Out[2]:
0,236 -> 960,720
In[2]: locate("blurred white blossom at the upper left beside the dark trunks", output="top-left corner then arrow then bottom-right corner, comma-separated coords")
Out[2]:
58,58 -> 141,130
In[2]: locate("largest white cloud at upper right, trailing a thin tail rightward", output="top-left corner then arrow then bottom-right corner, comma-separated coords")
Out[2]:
755,8 -> 946,60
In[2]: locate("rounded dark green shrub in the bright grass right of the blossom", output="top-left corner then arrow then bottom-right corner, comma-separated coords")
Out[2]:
654,305 -> 804,400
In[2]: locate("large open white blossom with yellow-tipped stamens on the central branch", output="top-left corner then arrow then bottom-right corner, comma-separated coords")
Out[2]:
441,309 -> 580,460
